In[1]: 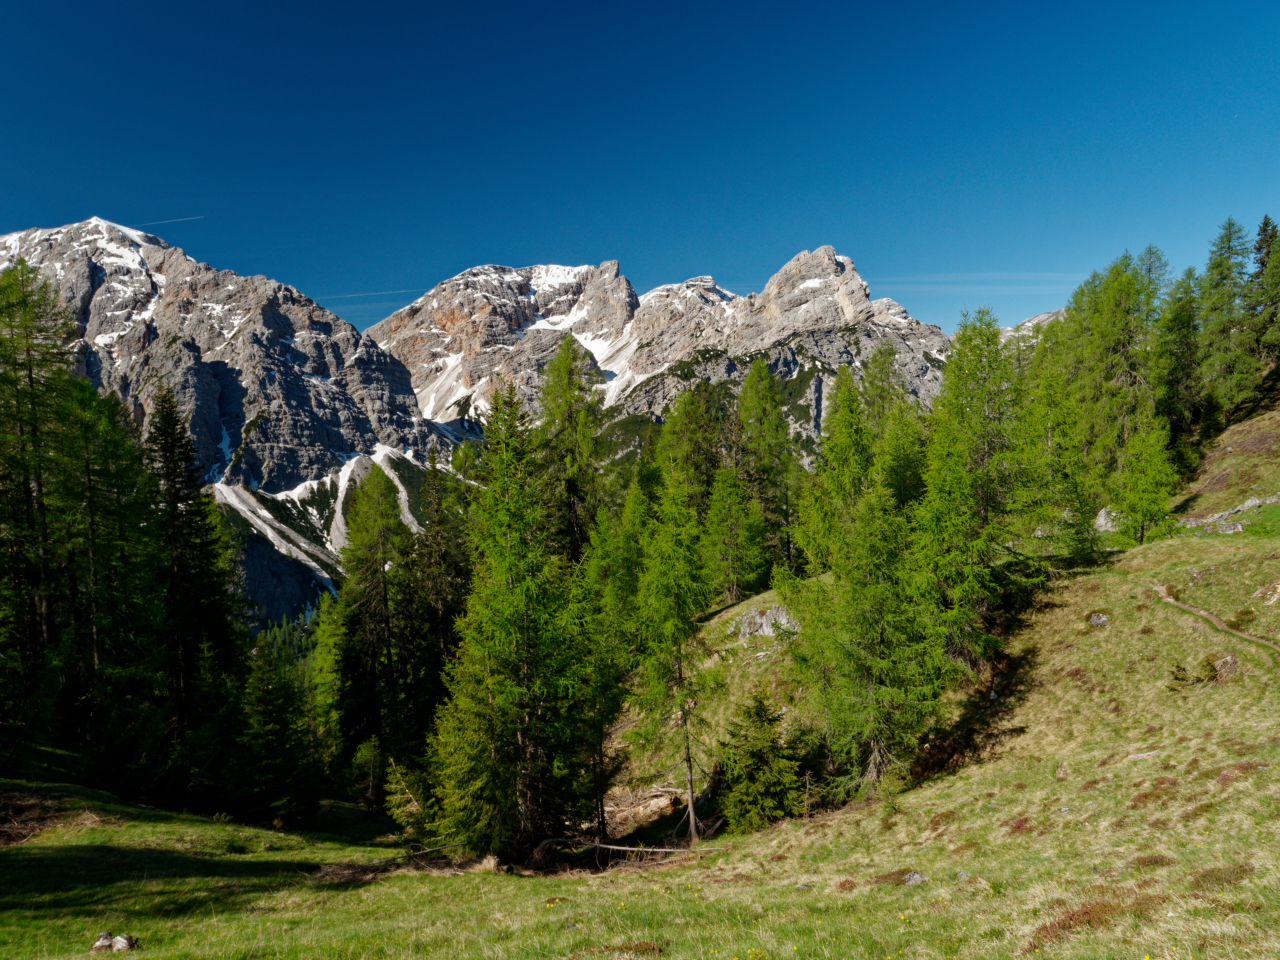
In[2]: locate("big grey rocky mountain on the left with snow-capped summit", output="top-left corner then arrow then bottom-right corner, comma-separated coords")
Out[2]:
0,218 -> 439,492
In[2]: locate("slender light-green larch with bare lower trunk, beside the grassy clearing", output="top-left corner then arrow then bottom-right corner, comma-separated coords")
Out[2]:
635,477 -> 710,842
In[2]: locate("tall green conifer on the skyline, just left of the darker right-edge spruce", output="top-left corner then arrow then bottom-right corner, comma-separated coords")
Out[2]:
1199,218 -> 1261,417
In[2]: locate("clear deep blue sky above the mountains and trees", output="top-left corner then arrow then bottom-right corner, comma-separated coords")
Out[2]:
0,3 -> 1280,332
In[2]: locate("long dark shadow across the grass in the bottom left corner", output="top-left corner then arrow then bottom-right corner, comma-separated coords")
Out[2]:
0,844 -> 320,918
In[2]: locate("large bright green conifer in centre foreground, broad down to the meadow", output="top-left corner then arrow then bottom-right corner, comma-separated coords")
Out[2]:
435,385 -> 580,852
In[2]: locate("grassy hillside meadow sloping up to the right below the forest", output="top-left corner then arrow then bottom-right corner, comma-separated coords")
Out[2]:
0,424 -> 1280,960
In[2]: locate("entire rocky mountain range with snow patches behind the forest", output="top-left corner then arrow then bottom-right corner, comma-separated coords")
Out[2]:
0,218 -> 988,621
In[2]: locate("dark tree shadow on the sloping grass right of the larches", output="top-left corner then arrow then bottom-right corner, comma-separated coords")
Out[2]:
911,646 -> 1039,780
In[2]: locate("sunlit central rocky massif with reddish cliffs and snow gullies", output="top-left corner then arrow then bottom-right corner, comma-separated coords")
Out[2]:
366,247 -> 948,438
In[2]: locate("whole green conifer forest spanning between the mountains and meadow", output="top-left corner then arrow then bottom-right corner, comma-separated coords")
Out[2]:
0,218 -> 1280,863
